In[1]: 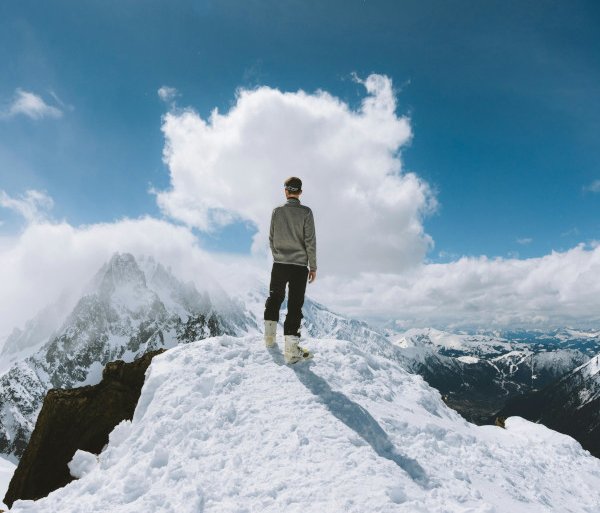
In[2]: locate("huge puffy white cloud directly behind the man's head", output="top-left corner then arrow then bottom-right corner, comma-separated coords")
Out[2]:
157,75 -> 436,275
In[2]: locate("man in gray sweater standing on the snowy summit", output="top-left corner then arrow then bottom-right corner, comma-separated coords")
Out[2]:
264,176 -> 317,363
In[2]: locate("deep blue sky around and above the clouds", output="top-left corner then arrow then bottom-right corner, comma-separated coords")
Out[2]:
0,0 -> 600,261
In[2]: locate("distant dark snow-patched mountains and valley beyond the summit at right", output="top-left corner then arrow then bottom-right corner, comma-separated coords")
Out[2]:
386,328 -> 600,424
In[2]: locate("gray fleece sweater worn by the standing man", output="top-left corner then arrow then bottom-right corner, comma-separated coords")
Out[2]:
269,198 -> 317,271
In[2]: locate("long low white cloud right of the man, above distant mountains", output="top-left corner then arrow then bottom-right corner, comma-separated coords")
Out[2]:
315,244 -> 600,327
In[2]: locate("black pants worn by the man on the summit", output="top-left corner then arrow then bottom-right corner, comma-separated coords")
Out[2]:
265,262 -> 308,337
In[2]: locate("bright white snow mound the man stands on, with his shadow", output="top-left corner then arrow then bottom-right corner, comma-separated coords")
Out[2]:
11,335 -> 600,513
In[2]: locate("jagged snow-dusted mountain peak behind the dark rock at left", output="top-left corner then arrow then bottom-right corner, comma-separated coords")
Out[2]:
0,253 -> 256,457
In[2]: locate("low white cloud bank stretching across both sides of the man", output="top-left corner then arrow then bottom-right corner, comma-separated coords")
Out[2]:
0,213 -> 600,335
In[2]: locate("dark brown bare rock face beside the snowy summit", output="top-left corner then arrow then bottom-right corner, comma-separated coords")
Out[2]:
4,348 -> 164,507
